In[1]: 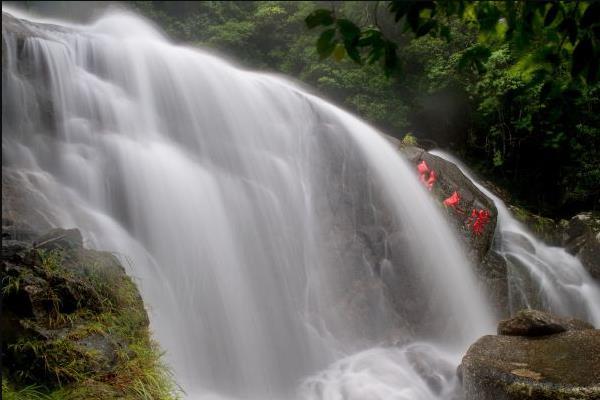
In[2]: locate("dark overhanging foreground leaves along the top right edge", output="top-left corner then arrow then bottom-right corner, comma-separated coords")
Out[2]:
305,0 -> 600,83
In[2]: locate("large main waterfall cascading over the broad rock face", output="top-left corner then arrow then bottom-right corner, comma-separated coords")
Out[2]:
2,7 -> 493,400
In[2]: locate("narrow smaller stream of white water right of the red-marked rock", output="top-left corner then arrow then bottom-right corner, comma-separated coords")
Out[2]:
430,151 -> 600,327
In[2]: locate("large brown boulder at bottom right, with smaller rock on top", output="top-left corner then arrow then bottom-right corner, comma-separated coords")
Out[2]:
460,311 -> 600,400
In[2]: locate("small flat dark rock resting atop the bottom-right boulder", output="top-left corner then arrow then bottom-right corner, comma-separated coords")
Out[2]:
498,310 -> 594,336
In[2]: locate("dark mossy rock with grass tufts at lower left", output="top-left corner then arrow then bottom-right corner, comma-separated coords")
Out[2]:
1,229 -> 177,400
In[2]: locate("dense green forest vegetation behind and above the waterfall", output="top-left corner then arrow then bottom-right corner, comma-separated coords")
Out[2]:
18,0 -> 600,217
